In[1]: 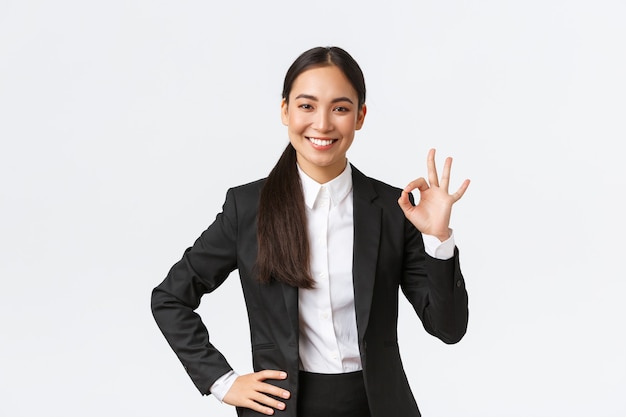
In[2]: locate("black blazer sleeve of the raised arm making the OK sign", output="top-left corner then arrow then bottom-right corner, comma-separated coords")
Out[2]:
401,213 -> 468,344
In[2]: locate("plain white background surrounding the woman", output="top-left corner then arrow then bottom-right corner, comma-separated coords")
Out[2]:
0,0 -> 626,417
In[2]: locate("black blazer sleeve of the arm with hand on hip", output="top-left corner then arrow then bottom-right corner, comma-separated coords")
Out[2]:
151,189 -> 237,395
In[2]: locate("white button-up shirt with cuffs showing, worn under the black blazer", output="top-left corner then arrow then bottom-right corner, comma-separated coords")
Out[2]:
211,163 -> 455,401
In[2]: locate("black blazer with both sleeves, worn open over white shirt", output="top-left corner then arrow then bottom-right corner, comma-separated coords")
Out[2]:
152,167 -> 468,417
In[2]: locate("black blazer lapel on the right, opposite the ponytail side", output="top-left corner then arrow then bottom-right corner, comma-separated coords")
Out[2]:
352,166 -> 381,341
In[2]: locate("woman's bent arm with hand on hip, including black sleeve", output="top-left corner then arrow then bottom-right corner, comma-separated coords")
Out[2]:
152,190 -> 290,415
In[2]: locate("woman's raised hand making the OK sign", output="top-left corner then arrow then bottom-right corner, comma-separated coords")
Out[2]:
398,149 -> 470,242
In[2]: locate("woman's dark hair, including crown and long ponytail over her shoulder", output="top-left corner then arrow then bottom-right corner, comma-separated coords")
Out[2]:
256,46 -> 365,288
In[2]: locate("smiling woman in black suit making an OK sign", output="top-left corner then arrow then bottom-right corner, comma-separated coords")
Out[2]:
152,47 -> 469,417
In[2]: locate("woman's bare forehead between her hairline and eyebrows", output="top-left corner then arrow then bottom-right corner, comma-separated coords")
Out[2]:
290,65 -> 357,99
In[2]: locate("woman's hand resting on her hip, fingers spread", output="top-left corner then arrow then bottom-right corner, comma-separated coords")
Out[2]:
224,370 -> 291,415
